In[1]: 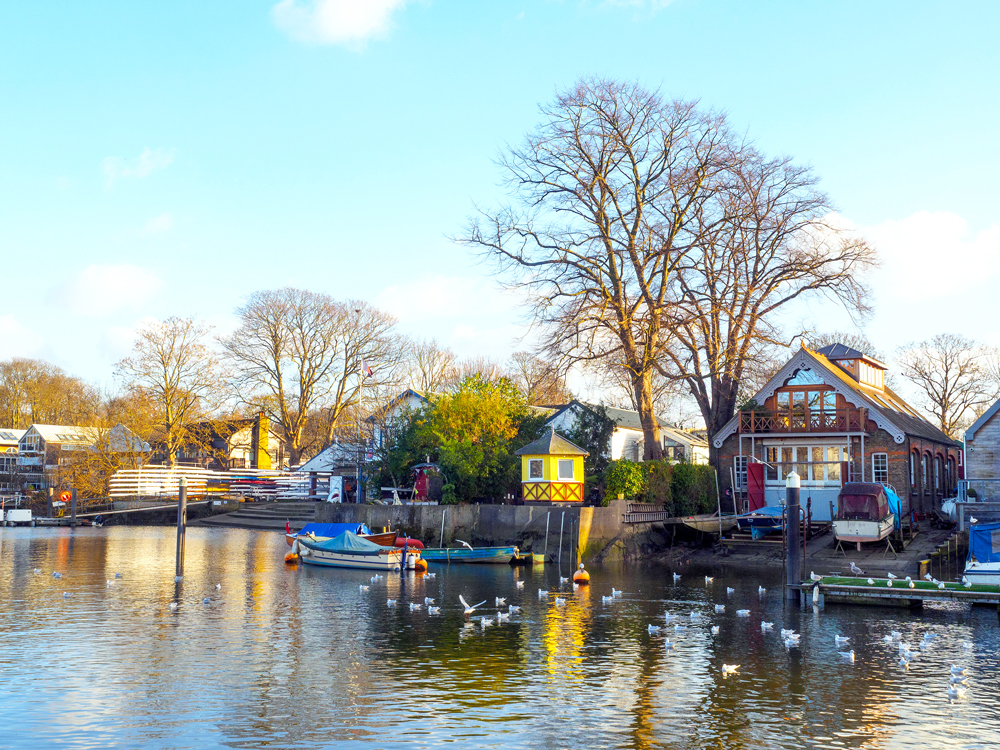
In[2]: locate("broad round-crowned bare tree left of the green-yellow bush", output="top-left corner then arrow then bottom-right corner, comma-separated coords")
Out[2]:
222,288 -> 401,465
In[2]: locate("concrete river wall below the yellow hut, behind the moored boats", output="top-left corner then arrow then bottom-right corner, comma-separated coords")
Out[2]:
316,500 -> 667,562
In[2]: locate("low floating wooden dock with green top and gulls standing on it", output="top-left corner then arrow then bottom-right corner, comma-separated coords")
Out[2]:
789,578 -> 1000,614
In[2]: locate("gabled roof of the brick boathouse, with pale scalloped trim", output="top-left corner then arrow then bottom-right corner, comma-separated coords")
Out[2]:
712,346 -> 960,448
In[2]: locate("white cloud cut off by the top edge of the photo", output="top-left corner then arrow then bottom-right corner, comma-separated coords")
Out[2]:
271,0 -> 407,48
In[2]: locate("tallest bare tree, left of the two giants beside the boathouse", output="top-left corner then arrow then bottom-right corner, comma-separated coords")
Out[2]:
460,79 -> 732,459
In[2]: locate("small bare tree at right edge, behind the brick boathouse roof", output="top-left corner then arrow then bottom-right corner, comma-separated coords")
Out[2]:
897,333 -> 997,440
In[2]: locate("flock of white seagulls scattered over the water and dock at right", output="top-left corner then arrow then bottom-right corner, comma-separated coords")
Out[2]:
359,562 -> 973,700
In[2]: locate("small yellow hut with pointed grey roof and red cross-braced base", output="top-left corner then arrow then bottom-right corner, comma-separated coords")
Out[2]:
515,427 -> 590,503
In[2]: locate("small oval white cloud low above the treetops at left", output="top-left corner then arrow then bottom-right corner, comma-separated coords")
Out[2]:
57,265 -> 163,318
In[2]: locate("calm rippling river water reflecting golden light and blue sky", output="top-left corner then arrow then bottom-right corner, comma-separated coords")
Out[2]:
0,527 -> 1000,748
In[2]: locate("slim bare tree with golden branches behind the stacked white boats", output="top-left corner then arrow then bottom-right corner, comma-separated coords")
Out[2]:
117,317 -> 221,466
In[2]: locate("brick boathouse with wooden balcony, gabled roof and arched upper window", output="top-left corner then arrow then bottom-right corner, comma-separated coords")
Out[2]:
712,344 -> 962,520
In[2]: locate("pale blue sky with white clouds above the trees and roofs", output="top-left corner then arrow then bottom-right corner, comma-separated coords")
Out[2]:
0,0 -> 1000,412
